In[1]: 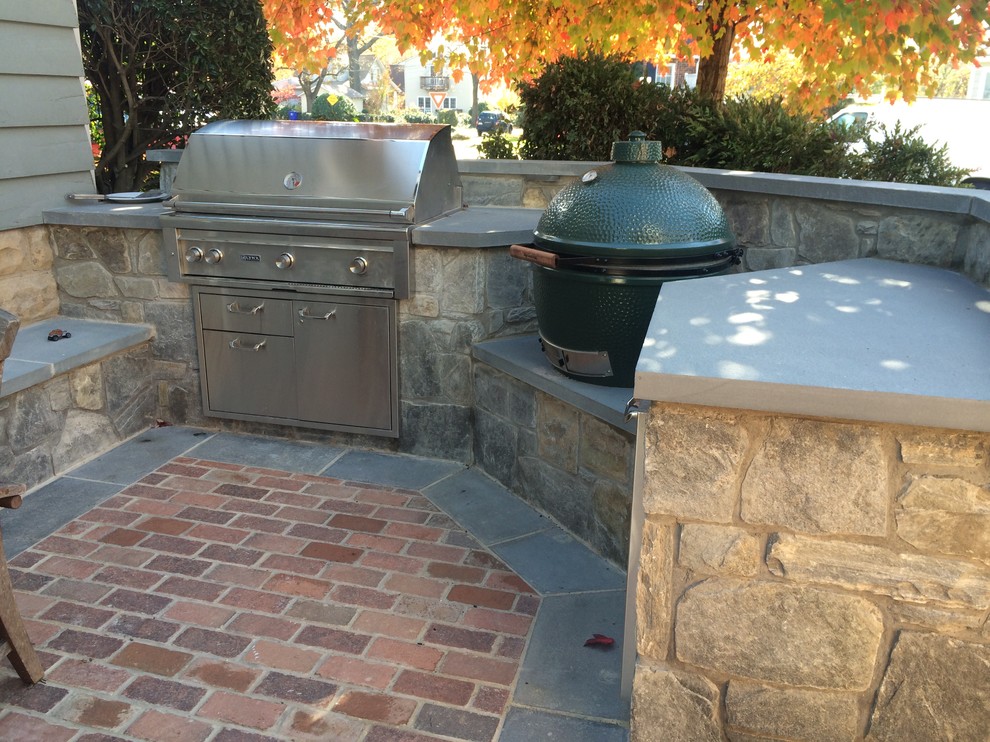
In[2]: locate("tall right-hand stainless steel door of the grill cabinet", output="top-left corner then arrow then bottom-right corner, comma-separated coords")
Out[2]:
293,301 -> 395,430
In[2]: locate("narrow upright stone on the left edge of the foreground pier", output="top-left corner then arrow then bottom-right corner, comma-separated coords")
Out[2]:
636,518 -> 676,660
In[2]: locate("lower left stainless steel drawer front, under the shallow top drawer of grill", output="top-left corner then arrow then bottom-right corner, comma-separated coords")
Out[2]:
203,330 -> 297,419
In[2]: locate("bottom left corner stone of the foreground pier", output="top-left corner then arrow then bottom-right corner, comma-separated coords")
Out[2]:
629,663 -> 722,742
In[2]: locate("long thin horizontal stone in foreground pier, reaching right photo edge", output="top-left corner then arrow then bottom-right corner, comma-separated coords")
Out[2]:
767,534 -> 990,609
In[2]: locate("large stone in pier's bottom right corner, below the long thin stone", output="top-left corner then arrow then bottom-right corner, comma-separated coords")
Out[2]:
866,631 -> 990,742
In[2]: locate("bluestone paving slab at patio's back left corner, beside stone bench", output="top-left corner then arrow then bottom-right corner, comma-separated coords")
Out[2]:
71,426 -> 213,485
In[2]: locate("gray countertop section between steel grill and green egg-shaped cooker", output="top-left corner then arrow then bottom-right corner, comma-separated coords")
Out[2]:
412,206 -> 543,247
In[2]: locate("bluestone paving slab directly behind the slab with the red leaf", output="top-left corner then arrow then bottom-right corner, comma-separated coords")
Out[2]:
489,527 -> 626,595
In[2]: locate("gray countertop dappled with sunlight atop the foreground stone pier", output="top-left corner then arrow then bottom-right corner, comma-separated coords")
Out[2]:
635,259 -> 990,431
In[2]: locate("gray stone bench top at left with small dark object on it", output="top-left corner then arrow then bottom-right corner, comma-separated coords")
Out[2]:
0,316 -> 154,398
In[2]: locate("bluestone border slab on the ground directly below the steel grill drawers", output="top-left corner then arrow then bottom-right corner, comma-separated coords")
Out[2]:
186,433 -> 345,474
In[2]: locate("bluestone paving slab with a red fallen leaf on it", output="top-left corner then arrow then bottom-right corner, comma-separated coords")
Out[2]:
513,590 -> 629,721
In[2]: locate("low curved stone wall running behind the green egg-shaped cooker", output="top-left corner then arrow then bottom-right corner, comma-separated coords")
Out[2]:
460,160 -> 990,286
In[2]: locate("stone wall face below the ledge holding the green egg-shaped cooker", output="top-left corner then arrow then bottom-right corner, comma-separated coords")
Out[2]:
474,364 -> 635,567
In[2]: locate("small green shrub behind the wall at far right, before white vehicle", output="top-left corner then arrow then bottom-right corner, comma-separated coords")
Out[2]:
849,122 -> 972,186
